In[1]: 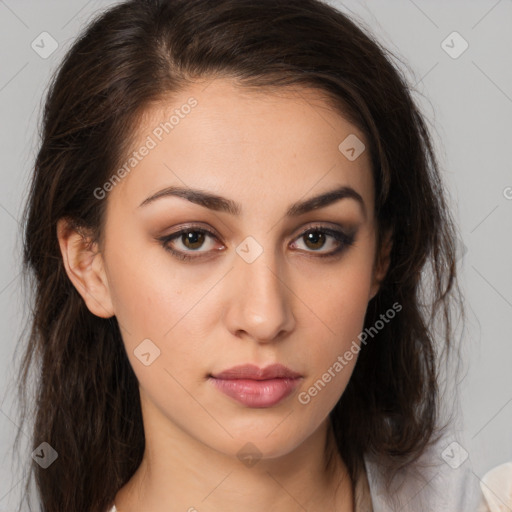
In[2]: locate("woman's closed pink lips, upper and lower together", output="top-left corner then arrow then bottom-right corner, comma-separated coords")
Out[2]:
209,364 -> 302,408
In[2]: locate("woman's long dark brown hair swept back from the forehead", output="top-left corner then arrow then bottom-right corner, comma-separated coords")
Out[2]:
14,0 -> 466,512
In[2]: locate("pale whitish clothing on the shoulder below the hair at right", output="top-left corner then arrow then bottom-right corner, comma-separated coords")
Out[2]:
364,436 -> 489,512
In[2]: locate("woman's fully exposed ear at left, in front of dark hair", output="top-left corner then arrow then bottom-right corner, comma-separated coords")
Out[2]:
57,218 -> 114,318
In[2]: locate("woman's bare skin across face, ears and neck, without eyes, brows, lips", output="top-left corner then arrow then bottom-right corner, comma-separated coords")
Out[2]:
58,79 -> 390,512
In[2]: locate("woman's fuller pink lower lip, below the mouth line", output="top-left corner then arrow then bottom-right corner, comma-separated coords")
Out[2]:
209,377 -> 301,407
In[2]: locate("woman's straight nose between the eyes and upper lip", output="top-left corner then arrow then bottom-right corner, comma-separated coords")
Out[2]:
225,244 -> 295,343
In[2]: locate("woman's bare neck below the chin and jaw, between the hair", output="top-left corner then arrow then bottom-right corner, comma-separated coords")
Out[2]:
115,400 -> 354,512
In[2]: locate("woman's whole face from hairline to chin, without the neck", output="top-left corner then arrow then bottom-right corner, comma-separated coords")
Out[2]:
60,79 -> 385,457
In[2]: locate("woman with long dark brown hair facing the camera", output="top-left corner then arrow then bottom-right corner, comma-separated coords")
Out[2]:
15,0 -> 488,512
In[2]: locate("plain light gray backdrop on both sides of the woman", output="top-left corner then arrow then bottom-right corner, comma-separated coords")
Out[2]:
0,0 -> 512,511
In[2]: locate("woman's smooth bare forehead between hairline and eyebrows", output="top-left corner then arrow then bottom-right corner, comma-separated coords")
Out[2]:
108,79 -> 374,219
